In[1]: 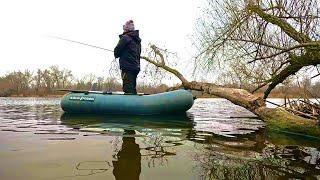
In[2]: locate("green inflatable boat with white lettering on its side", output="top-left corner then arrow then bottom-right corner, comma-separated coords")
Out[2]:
61,90 -> 193,115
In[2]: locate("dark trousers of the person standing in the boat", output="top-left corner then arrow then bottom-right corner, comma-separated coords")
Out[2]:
121,71 -> 138,94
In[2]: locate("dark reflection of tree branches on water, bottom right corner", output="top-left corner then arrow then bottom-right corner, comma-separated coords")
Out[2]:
194,131 -> 320,179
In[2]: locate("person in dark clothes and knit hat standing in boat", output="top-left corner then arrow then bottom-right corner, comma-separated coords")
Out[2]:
114,20 -> 141,94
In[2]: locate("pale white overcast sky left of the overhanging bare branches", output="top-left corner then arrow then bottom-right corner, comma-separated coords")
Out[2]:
0,0 -> 200,81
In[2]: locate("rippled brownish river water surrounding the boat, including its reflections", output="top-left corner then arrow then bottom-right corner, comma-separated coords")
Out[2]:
0,98 -> 320,180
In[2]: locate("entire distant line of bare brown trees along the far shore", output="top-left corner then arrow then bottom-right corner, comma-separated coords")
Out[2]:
0,66 -> 320,98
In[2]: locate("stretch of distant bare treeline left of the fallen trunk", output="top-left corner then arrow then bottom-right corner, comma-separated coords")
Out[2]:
0,66 -> 168,96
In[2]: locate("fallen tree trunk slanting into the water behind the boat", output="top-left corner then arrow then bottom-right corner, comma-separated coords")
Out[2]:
141,54 -> 320,138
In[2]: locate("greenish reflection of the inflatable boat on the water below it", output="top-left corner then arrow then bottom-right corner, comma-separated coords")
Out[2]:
61,113 -> 194,138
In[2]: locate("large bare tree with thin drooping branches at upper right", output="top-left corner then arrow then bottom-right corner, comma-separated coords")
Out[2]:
197,0 -> 320,98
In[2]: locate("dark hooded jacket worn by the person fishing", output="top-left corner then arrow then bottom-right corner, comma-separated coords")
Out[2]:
114,30 -> 141,73
